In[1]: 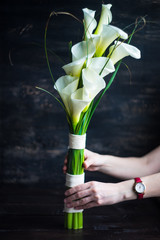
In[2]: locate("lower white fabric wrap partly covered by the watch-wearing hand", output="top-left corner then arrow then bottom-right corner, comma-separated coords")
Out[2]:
64,173 -> 85,213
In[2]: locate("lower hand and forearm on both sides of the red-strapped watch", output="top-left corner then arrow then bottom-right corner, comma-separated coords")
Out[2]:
64,173 -> 160,210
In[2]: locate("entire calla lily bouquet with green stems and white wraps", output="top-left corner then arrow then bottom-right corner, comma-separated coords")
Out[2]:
39,4 -> 140,229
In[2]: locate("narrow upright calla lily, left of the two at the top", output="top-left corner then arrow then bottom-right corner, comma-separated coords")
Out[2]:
82,8 -> 97,38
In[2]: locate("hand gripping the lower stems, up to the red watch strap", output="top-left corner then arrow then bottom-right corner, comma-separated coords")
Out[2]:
64,180 -> 136,210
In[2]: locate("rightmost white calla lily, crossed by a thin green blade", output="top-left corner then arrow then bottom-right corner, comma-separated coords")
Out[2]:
109,41 -> 141,64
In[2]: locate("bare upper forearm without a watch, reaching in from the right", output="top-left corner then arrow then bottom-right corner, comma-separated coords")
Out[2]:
99,147 -> 160,179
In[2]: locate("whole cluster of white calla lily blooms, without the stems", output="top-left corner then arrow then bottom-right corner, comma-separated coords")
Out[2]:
54,4 -> 140,126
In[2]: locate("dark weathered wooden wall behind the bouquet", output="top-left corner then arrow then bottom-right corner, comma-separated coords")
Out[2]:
0,0 -> 160,184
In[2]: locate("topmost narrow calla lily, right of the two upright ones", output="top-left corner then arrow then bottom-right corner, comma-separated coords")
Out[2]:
94,4 -> 112,34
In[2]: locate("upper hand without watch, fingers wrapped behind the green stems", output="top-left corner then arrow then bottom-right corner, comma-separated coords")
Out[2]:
63,149 -> 105,173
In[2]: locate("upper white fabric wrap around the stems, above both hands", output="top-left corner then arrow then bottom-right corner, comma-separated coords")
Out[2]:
69,133 -> 86,149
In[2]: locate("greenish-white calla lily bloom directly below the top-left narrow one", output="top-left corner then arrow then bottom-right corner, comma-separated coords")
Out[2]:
71,40 -> 96,62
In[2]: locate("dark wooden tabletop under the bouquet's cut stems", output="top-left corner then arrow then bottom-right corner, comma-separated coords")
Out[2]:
0,186 -> 160,240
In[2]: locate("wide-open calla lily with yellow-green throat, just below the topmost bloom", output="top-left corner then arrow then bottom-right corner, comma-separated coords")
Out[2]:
96,25 -> 128,57
